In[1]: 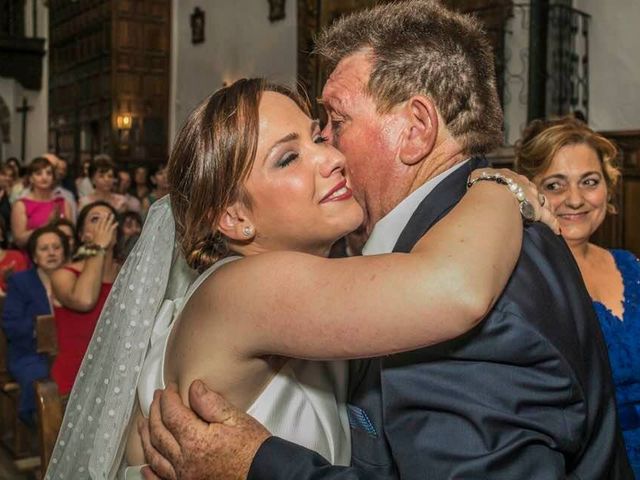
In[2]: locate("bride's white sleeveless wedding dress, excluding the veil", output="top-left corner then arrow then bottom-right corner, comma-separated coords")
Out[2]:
126,257 -> 351,480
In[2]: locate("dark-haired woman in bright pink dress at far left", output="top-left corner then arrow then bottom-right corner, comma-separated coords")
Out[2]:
11,157 -> 72,247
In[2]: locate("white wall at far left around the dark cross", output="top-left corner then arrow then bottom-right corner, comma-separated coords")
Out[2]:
0,0 -> 49,164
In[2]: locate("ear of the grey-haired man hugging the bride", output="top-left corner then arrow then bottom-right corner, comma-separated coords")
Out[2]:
399,95 -> 438,165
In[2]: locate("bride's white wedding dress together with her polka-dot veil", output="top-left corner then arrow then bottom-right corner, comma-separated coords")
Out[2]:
45,195 -> 351,480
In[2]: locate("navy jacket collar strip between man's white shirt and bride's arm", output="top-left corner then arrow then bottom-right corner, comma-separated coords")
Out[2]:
393,157 -> 487,253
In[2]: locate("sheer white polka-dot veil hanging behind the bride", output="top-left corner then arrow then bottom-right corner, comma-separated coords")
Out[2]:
45,195 -> 195,480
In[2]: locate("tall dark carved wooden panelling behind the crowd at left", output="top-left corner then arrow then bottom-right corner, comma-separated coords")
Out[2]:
49,0 -> 171,169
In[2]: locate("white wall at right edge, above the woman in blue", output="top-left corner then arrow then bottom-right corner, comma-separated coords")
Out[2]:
574,0 -> 640,130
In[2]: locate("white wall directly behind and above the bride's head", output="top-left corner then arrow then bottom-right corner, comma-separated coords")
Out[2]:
169,0 -> 297,143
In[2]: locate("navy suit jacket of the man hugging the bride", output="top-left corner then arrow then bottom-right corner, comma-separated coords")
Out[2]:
249,159 -> 633,480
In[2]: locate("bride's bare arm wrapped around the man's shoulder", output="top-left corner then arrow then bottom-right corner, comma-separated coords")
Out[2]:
189,178 -> 536,359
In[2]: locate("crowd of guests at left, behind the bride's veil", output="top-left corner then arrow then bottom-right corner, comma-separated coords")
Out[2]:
0,154 -> 152,425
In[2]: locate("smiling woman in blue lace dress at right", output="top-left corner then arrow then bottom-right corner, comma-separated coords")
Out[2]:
516,117 -> 640,478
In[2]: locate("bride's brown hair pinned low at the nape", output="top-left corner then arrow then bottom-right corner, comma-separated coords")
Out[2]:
167,78 -> 308,271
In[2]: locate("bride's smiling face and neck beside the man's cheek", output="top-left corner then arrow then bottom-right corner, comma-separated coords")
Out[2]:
245,92 -> 363,255
